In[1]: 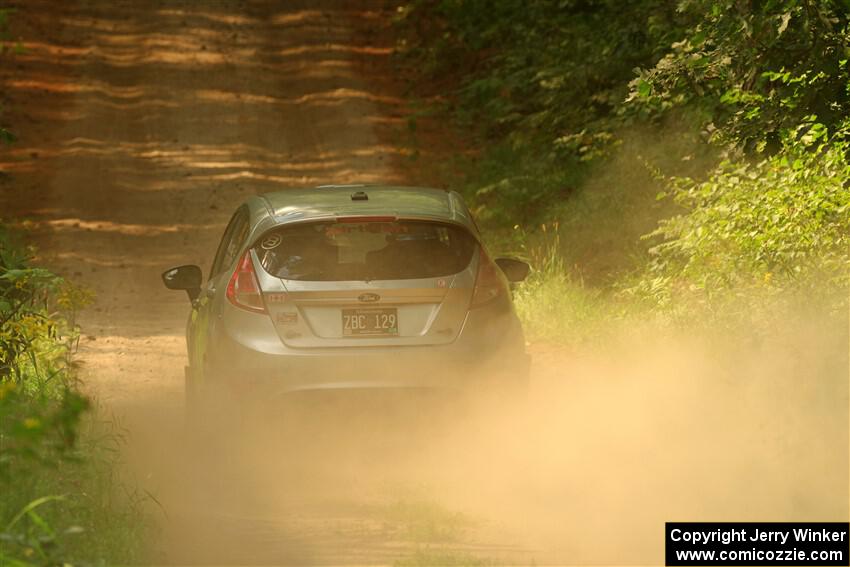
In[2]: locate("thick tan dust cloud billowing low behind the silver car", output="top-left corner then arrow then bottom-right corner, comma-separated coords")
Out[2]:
114,300 -> 850,565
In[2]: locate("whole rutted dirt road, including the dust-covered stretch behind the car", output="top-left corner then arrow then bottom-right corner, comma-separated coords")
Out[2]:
0,0 -> 848,564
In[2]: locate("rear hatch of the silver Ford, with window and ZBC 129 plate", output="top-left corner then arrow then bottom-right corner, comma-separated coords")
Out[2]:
254,217 -> 478,348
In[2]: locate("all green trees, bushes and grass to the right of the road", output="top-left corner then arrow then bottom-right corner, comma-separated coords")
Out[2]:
400,0 -> 850,332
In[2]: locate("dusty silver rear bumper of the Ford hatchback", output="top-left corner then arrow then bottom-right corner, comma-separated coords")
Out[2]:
204,318 -> 530,398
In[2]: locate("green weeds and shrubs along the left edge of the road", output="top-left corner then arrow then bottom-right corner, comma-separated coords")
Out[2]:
0,224 -> 146,565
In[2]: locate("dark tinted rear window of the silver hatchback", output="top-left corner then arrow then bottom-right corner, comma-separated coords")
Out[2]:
256,221 -> 475,281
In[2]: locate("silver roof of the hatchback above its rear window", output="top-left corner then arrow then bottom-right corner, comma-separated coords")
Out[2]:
255,185 -> 474,226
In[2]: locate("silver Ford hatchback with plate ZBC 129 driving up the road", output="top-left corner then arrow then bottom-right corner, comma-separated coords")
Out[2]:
162,185 -> 529,410
